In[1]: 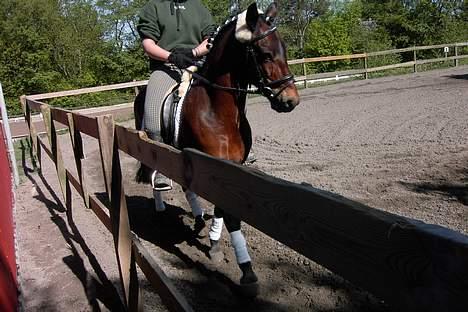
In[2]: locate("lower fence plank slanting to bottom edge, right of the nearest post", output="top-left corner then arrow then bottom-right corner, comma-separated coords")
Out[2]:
132,236 -> 193,312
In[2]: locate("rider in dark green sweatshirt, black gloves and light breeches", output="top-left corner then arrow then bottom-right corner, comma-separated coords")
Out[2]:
137,0 -> 215,191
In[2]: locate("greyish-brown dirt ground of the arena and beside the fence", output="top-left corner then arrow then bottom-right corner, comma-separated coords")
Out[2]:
15,67 -> 468,312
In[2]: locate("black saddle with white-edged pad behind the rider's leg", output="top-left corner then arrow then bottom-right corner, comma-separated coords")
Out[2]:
160,66 -> 197,147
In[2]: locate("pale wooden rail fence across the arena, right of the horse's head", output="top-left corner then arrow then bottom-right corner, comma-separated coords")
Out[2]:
288,42 -> 468,87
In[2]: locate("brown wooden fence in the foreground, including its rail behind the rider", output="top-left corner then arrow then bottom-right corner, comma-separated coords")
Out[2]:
21,42 -> 468,311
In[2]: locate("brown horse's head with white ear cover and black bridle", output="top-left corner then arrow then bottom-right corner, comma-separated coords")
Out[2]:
235,3 -> 299,112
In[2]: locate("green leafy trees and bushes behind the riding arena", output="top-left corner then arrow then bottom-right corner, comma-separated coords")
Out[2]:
0,0 -> 468,115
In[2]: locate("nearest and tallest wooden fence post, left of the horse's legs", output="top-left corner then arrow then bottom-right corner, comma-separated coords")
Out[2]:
96,115 -> 141,311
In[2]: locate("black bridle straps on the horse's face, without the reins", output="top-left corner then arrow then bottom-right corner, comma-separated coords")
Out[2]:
247,26 -> 294,99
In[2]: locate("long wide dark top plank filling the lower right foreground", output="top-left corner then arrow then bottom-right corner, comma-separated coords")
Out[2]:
184,150 -> 468,311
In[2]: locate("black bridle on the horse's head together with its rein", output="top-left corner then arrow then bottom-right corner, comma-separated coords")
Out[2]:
185,18 -> 294,100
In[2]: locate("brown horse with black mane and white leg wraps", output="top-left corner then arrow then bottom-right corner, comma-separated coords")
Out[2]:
135,3 -> 299,294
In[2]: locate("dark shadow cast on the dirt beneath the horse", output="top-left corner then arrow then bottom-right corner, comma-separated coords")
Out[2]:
103,193 -> 287,311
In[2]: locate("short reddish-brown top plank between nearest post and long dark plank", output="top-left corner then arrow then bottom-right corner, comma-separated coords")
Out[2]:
115,126 -> 185,186
